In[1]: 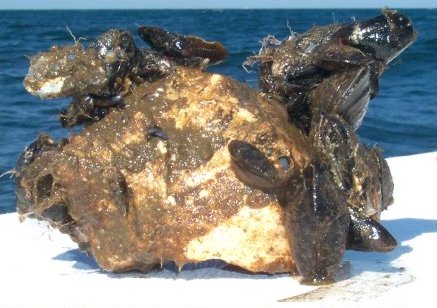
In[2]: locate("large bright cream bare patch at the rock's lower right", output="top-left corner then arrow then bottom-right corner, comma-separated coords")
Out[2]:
185,203 -> 292,272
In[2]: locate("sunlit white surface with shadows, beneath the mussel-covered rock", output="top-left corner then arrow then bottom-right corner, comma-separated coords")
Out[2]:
0,152 -> 437,307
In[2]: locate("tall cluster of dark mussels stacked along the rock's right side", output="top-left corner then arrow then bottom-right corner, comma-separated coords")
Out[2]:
238,9 -> 417,282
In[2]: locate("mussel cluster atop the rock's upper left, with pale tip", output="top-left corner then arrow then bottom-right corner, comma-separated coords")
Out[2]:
24,26 -> 227,127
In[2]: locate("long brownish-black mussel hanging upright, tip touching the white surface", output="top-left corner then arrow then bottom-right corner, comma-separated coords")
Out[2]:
284,161 -> 350,284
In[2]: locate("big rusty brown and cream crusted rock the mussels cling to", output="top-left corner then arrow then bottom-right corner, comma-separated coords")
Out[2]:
19,67 -> 311,273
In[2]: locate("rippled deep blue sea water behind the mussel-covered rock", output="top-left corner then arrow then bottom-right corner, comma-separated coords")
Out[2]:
0,9 -> 437,213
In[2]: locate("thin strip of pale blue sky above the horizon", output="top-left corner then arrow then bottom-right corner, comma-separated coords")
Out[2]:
0,0 -> 437,10
